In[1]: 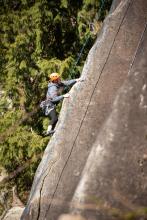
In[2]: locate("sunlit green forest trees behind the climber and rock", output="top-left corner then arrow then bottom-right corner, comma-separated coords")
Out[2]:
0,0 -> 112,210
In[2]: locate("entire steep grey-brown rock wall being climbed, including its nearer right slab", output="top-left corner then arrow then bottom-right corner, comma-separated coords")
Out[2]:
21,0 -> 147,220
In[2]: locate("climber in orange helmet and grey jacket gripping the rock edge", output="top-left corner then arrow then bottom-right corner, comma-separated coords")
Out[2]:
40,73 -> 83,136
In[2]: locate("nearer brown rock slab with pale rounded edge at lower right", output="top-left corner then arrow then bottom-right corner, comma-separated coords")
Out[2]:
71,22 -> 147,220
